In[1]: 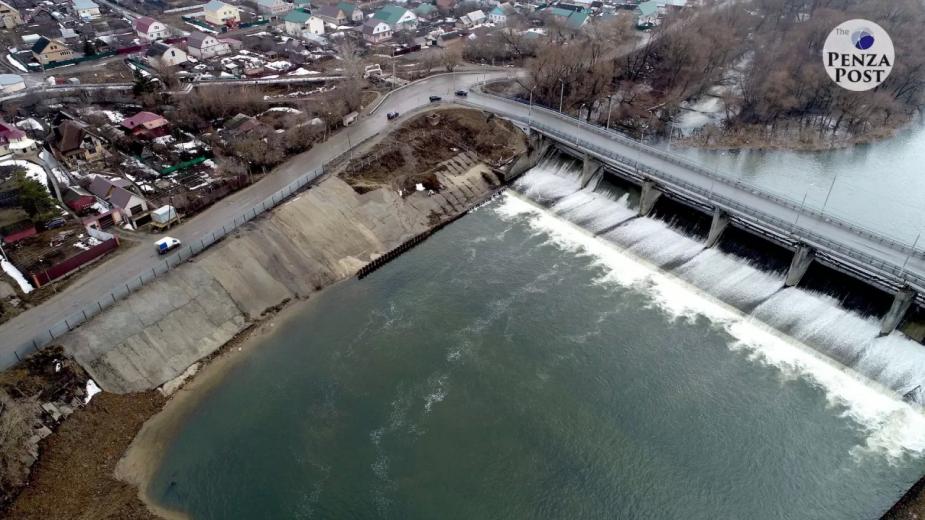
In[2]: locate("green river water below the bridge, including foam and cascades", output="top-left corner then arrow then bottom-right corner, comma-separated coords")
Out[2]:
148,160 -> 925,519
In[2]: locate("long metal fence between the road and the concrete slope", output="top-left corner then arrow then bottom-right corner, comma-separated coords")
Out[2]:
0,165 -> 326,369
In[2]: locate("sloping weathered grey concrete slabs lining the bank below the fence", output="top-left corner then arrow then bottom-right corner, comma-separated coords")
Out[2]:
61,165 -> 497,393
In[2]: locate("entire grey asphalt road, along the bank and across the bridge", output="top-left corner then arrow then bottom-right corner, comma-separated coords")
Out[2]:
0,67 -> 925,364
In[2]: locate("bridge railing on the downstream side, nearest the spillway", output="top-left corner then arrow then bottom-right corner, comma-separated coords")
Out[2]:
530,117 -> 925,287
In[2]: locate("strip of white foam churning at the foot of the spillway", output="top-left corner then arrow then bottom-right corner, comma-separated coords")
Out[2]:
495,193 -> 925,458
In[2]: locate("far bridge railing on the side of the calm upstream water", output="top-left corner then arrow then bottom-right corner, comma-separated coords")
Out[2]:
478,91 -> 923,254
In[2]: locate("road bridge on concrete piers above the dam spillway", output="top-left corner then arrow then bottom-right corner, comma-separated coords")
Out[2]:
463,92 -> 925,334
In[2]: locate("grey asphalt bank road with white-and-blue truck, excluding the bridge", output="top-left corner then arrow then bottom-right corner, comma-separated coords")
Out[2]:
0,71 -> 510,366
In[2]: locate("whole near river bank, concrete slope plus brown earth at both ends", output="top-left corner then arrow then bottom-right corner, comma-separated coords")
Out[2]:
0,110 -> 526,518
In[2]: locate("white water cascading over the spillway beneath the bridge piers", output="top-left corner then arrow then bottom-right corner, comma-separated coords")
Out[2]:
515,157 -> 925,405
